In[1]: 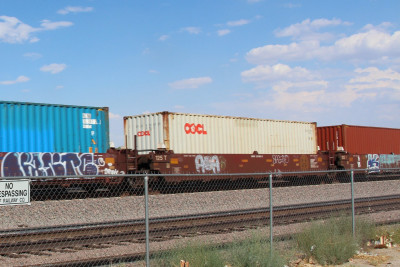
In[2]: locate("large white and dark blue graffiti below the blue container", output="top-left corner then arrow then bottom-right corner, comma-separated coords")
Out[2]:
1,152 -> 120,177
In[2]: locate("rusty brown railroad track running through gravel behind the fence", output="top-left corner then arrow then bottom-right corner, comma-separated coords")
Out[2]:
0,195 -> 400,266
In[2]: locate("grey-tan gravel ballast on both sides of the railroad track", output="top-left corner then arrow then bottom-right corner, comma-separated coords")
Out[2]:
0,181 -> 400,266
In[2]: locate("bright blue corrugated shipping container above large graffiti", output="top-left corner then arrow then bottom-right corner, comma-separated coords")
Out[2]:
0,101 -> 110,153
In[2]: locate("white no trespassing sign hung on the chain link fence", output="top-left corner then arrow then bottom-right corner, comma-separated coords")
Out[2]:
0,180 -> 31,205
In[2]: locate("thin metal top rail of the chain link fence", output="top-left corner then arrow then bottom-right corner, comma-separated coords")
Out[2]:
0,168 -> 400,181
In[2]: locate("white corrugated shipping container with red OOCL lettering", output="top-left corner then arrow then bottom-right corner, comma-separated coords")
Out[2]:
124,112 -> 317,154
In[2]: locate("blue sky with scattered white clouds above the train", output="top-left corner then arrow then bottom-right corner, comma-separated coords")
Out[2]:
0,0 -> 400,146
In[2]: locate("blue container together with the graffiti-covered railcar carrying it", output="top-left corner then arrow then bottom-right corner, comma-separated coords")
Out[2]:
0,101 -> 125,186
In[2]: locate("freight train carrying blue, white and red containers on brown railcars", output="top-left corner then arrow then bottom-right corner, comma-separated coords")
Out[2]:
0,101 -> 400,192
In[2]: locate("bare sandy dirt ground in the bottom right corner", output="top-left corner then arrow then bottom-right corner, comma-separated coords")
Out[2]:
294,246 -> 400,267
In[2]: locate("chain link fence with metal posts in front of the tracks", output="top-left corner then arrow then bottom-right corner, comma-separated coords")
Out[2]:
0,169 -> 400,266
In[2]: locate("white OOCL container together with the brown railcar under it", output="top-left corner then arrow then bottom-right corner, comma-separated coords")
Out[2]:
124,112 -> 327,182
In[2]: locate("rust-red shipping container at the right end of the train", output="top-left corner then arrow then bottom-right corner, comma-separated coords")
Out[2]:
317,124 -> 400,154
